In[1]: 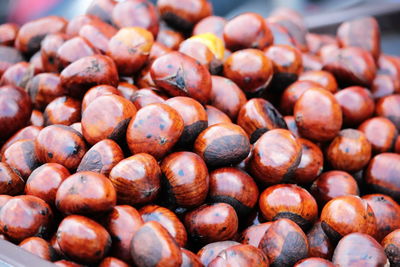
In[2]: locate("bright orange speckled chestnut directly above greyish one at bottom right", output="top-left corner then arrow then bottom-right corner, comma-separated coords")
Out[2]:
320,195 -> 377,241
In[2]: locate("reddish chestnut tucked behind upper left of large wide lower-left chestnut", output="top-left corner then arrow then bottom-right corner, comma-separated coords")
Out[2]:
25,163 -> 70,206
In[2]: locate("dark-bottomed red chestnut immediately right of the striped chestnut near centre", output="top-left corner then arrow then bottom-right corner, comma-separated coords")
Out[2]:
208,167 -> 259,218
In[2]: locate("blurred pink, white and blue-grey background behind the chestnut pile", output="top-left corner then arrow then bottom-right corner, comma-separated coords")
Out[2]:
0,0 -> 400,55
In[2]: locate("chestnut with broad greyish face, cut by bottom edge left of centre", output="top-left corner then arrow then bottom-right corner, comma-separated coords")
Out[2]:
131,221 -> 182,267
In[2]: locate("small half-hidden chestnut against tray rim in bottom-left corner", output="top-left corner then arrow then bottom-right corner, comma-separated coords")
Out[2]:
18,237 -> 56,261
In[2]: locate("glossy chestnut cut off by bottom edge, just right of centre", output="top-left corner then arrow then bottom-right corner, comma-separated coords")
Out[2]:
207,245 -> 269,267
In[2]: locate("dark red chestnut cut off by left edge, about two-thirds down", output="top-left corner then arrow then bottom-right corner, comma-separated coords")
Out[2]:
0,162 -> 25,196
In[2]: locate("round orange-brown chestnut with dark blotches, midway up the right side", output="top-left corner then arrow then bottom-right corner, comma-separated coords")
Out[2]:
326,129 -> 372,172
